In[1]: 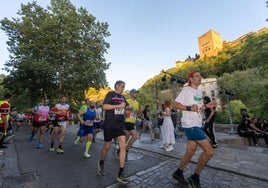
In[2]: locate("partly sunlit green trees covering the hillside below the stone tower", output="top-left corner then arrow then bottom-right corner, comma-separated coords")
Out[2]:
141,29 -> 268,121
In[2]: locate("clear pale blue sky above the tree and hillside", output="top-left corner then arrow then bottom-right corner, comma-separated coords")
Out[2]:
0,0 -> 268,90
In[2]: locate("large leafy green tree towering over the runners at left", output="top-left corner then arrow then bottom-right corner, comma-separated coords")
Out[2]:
1,0 -> 110,106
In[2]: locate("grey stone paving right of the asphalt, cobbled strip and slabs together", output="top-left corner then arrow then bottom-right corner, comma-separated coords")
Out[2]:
104,131 -> 268,188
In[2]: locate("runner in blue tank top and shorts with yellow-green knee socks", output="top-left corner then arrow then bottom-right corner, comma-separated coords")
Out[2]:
74,101 -> 96,158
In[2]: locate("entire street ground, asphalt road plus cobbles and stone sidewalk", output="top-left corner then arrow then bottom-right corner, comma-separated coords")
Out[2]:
0,126 -> 268,188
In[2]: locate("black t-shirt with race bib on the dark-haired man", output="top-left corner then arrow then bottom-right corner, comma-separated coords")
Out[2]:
103,91 -> 127,129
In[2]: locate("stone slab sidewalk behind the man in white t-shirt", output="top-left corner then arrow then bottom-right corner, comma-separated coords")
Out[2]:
129,133 -> 268,182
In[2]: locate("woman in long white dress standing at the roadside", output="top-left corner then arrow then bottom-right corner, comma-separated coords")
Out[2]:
161,107 -> 175,151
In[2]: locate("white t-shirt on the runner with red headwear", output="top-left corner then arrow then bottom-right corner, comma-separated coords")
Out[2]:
175,86 -> 203,128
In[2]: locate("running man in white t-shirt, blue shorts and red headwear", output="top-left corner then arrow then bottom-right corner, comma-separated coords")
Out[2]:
172,71 -> 216,187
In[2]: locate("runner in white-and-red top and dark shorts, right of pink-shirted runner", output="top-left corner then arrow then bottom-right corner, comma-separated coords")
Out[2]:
49,96 -> 70,154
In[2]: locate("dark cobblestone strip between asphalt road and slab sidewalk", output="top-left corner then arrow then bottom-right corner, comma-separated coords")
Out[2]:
107,149 -> 268,188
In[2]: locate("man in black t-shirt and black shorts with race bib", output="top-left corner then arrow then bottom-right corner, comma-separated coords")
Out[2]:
98,80 -> 128,184
